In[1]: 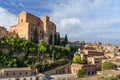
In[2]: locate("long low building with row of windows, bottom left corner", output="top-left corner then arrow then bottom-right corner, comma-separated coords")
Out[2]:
1,67 -> 36,78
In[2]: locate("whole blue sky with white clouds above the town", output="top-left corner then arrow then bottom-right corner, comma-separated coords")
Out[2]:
0,0 -> 120,44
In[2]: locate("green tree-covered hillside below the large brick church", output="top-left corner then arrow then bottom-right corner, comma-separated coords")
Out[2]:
0,36 -> 73,72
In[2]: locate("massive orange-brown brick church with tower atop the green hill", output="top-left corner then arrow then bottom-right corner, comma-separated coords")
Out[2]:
10,11 -> 58,42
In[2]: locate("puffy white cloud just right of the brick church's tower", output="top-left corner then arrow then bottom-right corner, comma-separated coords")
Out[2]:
59,18 -> 82,37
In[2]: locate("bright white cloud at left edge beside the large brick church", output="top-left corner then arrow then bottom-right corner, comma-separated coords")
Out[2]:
0,7 -> 17,30
